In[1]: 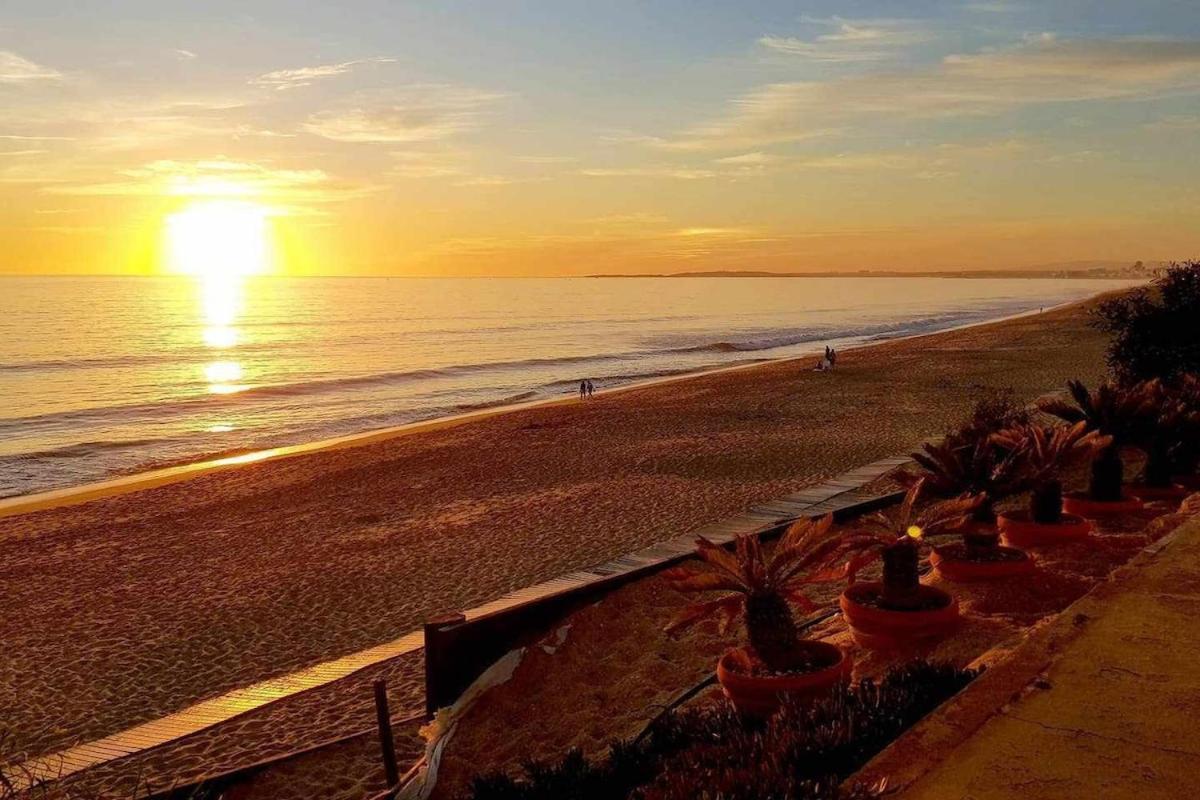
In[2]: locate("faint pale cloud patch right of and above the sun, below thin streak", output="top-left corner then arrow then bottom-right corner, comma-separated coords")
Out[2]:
304,85 -> 503,143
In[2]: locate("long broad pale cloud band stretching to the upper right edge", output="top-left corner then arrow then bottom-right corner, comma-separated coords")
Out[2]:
671,35 -> 1200,149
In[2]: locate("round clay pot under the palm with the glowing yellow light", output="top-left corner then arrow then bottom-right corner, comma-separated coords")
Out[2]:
839,581 -> 959,650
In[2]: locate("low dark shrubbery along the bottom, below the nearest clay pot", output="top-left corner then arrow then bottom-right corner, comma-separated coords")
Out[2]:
467,661 -> 978,800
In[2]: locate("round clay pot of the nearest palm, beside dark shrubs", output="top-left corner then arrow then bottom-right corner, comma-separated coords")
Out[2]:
716,639 -> 853,717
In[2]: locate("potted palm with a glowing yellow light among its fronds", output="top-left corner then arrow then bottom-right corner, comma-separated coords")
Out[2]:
839,481 -> 980,649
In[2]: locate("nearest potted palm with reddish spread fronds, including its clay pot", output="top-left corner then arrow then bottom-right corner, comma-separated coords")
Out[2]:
664,516 -> 851,716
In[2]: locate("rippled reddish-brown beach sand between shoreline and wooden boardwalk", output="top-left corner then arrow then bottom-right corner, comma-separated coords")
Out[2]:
0,298 -> 1104,753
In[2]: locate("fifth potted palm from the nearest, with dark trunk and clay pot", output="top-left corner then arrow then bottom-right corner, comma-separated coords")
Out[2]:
1040,380 -> 1147,517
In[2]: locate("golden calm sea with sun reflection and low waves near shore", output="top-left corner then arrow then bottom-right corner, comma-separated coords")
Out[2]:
0,277 -> 1128,497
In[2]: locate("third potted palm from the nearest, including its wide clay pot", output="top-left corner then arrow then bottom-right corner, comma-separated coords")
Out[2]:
913,432 -> 1034,582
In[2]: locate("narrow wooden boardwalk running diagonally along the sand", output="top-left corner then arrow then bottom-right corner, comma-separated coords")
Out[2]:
4,456 -> 911,789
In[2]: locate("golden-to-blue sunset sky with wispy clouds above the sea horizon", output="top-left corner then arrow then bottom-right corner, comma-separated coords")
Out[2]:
0,0 -> 1200,276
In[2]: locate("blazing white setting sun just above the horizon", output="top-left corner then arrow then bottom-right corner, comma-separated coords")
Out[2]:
167,200 -> 268,277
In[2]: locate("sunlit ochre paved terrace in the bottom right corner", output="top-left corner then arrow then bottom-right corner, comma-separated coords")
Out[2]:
862,517 -> 1200,800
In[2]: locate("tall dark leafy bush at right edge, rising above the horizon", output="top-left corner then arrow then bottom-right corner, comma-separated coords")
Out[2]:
1094,261 -> 1200,383
